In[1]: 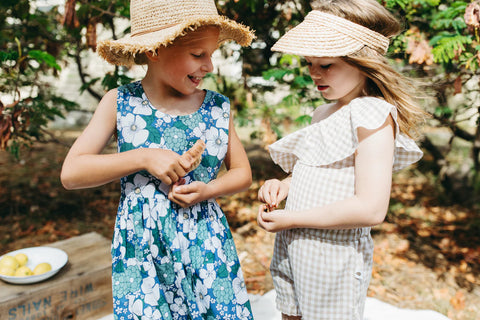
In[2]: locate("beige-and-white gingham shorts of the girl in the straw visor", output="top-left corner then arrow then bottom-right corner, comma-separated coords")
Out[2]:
270,228 -> 373,320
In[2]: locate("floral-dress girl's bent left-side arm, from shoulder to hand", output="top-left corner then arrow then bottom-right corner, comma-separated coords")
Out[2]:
60,89 -> 191,189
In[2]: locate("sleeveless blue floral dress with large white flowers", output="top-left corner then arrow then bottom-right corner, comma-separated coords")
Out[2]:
112,81 -> 253,320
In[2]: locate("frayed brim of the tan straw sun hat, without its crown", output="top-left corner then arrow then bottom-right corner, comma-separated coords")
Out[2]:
97,15 -> 255,66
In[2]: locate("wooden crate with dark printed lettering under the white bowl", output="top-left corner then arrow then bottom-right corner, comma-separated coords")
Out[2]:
0,232 -> 113,320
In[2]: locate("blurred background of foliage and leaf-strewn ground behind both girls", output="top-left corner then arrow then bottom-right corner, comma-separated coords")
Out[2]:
0,0 -> 480,319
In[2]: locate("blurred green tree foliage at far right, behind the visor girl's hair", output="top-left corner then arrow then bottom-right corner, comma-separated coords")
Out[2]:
384,0 -> 480,204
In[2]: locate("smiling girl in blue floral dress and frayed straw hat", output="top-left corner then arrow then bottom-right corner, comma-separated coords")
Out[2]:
61,0 -> 253,319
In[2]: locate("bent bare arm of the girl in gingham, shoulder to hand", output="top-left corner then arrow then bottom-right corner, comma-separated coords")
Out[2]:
259,117 -> 394,232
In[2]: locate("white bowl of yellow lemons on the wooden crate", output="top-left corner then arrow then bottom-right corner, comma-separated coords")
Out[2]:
0,247 -> 68,284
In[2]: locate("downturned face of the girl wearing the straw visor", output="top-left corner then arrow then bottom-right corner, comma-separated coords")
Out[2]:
305,57 -> 367,105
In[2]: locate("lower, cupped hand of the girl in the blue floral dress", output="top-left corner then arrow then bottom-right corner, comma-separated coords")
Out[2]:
168,179 -> 208,208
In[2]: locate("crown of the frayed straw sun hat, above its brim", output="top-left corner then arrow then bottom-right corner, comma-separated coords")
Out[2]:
130,0 -> 218,36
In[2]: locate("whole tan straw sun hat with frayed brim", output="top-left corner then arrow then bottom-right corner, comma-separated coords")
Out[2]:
97,0 -> 255,66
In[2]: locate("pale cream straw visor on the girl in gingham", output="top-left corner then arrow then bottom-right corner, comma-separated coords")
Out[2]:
272,10 -> 389,57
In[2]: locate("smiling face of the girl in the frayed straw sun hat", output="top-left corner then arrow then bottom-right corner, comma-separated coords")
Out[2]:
147,27 -> 219,95
